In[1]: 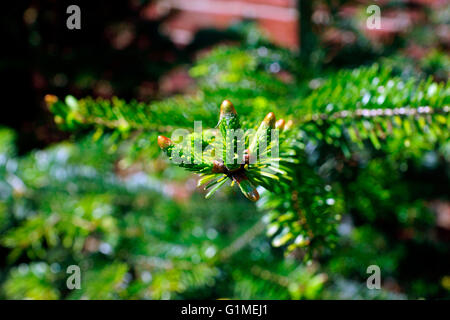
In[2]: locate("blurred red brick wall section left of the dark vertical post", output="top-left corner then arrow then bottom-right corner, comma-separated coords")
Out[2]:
147,0 -> 298,48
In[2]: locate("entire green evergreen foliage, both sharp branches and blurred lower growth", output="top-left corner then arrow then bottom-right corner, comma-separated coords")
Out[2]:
0,25 -> 450,299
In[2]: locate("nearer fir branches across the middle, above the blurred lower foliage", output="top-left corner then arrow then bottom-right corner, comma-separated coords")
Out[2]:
46,38 -> 450,258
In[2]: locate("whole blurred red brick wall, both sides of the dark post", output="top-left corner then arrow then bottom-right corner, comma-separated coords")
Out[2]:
144,0 -> 449,49
